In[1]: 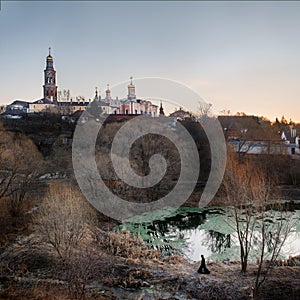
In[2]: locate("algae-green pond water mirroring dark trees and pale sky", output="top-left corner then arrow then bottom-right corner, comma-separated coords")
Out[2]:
126,208 -> 300,261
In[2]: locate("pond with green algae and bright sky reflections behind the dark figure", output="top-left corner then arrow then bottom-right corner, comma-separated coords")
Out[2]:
123,205 -> 300,261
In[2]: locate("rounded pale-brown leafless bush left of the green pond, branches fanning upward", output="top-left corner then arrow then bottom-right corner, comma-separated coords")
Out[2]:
36,183 -> 96,260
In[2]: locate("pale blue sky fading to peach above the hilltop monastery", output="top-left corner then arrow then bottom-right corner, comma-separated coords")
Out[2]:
0,0 -> 300,121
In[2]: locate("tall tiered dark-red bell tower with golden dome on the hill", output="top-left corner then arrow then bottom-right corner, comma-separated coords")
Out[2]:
43,48 -> 57,101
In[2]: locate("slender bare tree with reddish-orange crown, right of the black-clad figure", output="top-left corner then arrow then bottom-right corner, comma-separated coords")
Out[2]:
223,151 -> 271,273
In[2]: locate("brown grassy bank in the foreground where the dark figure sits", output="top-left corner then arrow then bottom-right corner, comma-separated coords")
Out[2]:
0,232 -> 300,300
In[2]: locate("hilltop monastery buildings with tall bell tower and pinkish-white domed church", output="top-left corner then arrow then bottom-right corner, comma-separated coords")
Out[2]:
4,48 -> 159,117
